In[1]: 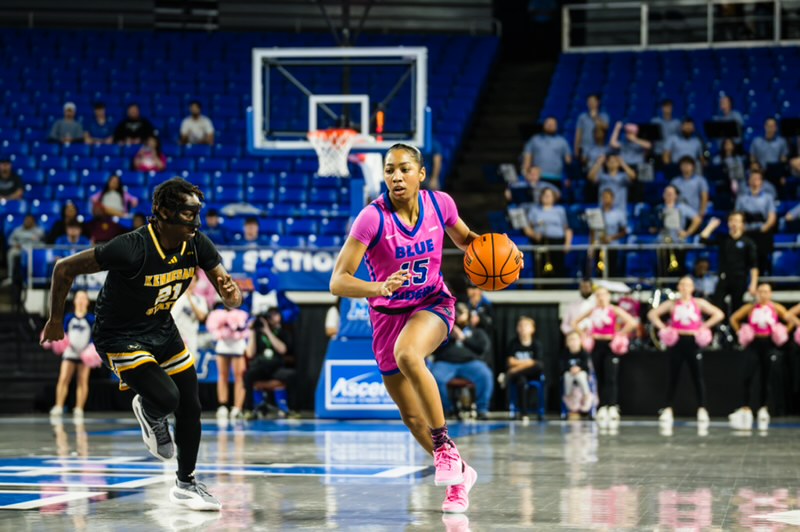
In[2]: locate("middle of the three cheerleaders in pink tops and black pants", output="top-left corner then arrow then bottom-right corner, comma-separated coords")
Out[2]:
647,275 -> 725,423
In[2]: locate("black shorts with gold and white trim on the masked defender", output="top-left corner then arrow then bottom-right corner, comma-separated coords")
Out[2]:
94,327 -> 194,390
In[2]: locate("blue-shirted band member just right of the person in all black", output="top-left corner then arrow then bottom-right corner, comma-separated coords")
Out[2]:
736,171 -> 777,275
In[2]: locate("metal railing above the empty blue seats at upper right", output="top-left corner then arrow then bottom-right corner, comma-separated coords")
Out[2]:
561,0 -> 800,52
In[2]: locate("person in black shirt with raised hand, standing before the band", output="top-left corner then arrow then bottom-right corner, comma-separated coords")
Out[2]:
700,212 -> 758,316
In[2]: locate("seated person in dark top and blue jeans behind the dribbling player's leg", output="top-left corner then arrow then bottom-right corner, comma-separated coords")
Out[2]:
431,303 -> 494,419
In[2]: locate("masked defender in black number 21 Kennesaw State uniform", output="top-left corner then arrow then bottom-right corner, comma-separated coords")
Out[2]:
43,177 -> 242,510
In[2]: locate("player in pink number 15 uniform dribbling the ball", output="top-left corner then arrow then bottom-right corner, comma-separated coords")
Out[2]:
330,144 -> 478,513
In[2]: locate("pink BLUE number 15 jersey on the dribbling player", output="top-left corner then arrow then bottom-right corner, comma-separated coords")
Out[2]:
350,190 -> 458,310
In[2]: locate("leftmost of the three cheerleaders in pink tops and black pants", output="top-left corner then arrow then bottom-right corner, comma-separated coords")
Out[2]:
572,288 -> 638,428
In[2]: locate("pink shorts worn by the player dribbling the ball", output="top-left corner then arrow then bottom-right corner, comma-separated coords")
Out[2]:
369,294 -> 456,375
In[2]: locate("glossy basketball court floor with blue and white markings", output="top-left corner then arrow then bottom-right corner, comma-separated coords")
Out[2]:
0,415 -> 800,532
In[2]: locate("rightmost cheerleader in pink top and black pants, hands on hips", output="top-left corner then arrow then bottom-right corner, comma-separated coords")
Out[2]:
728,283 -> 800,430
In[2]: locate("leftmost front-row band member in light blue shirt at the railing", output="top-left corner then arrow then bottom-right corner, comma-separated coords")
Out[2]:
523,190 -> 572,277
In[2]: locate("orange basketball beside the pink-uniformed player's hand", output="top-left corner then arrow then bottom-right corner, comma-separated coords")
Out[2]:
464,233 -> 522,291
